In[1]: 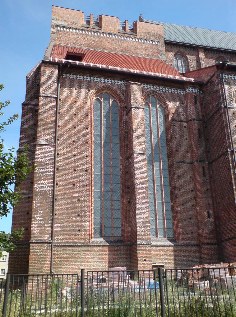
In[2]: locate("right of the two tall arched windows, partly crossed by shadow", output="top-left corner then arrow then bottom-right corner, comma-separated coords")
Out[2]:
145,96 -> 173,238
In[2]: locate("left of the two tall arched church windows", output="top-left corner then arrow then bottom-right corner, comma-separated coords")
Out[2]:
93,93 -> 121,239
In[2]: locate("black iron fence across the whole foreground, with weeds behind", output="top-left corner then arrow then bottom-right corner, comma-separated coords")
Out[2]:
0,267 -> 236,317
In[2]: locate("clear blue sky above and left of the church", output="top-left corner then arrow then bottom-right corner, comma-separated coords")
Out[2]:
0,0 -> 236,231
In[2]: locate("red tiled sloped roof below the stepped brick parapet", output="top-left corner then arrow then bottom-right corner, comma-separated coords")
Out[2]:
51,46 -> 180,76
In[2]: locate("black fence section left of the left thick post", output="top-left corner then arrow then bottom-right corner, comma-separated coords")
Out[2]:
0,274 -> 80,317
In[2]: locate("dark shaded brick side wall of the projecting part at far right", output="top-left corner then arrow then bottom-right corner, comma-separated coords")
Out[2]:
203,72 -> 236,261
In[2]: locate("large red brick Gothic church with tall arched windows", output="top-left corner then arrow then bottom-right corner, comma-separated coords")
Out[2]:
9,6 -> 236,274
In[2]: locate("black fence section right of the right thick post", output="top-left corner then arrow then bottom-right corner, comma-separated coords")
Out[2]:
165,267 -> 236,317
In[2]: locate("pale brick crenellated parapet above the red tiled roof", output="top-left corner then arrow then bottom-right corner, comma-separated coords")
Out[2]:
45,6 -> 165,60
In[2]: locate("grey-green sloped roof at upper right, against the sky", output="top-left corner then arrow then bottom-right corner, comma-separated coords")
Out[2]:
145,20 -> 236,51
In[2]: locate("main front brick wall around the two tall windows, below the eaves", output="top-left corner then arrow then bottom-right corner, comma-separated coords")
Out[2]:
12,64 -> 221,273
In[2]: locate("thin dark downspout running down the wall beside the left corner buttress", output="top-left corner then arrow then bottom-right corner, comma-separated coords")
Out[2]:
50,64 -> 62,274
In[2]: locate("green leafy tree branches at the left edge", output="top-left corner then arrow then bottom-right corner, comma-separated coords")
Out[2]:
0,84 -> 30,254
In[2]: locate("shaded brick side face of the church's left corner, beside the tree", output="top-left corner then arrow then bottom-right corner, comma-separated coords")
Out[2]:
9,66 -> 41,273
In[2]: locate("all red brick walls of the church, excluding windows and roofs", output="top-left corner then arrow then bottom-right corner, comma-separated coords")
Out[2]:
10,7 -> 236,273
